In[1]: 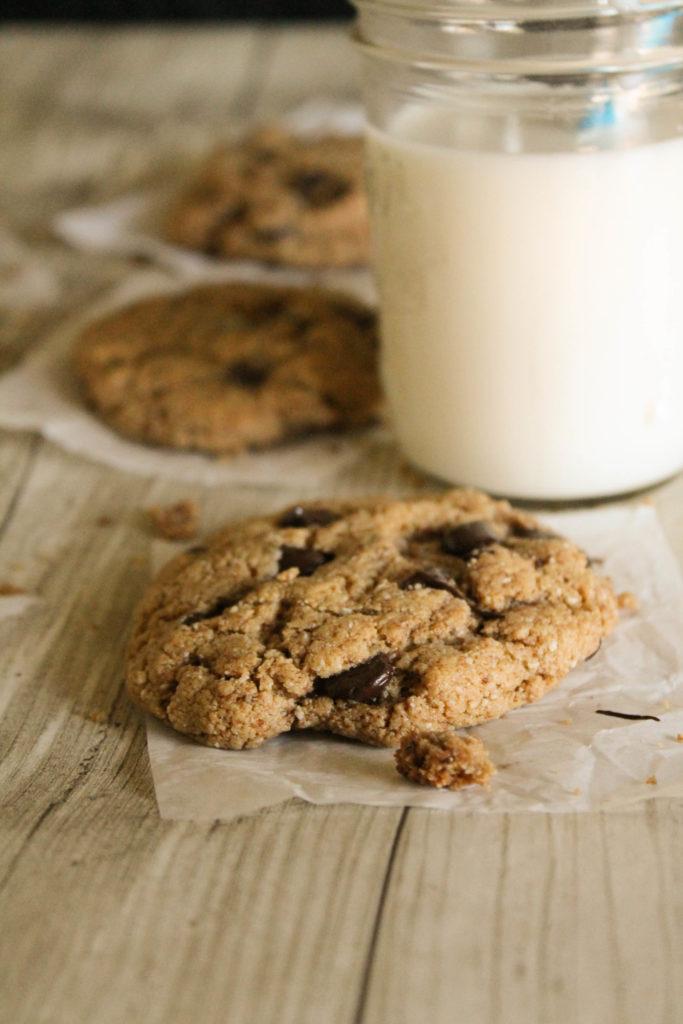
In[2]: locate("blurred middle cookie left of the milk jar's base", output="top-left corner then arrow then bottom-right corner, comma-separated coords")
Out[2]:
74,284 -> 380,454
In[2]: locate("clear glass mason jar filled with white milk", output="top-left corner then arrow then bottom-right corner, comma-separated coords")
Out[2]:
354,0 -> 683,500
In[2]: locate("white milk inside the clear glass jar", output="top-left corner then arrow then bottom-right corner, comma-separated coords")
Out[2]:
368,114 -> 683,499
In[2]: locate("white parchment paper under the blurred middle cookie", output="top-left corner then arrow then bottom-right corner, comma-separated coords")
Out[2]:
0,263 -> 388,486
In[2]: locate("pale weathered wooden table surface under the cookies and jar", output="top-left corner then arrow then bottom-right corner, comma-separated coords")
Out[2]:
0,26 -> 683,1024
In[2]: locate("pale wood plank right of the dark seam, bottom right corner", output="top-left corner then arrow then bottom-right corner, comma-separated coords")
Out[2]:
359,802 -> 683,1024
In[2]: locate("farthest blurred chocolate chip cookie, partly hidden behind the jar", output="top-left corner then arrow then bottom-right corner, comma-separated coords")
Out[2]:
166,128 -> 370,266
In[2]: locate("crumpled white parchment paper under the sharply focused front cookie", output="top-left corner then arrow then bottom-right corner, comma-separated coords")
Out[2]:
147,504 -> 683,820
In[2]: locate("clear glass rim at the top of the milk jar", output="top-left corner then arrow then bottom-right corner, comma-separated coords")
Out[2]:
352,0 -> 683,76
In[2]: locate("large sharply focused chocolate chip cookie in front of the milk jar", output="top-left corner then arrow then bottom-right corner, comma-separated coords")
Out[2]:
126,490 -> 617,749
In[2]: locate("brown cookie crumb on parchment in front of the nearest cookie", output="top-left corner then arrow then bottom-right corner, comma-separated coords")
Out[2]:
394,729 -> 496,790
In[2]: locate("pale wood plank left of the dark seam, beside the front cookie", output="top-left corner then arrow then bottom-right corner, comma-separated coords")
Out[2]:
0,445 -> 400,1024
